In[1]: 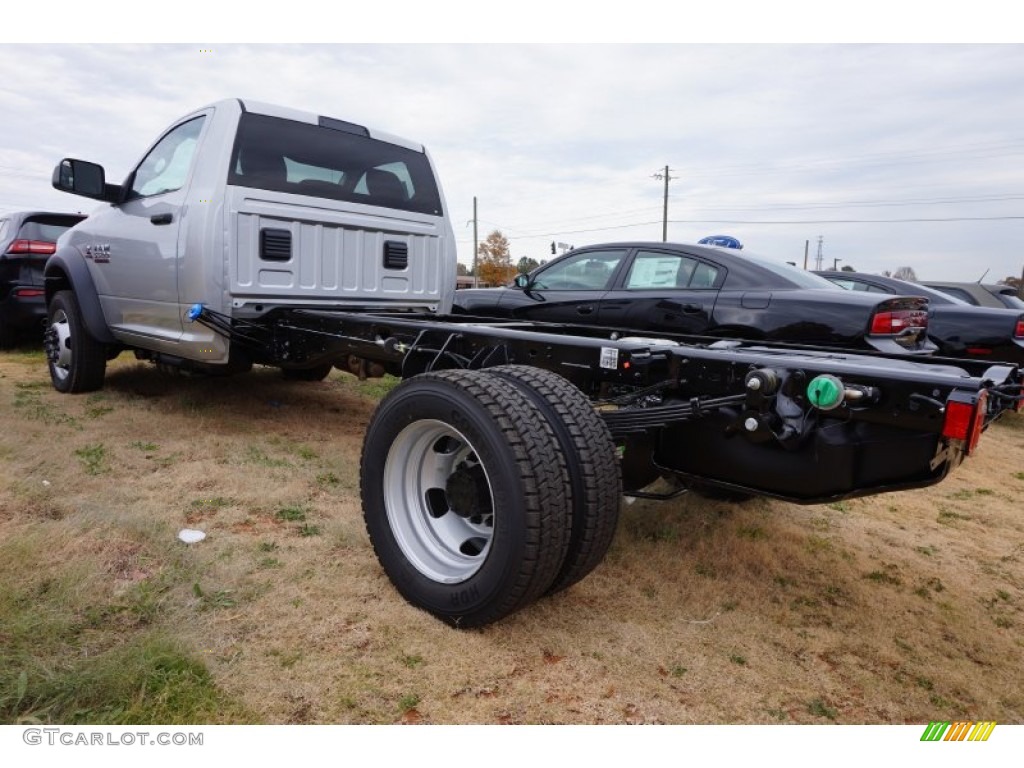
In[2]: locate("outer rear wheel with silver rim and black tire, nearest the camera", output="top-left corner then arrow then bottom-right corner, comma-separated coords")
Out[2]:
360,371 -> 569,628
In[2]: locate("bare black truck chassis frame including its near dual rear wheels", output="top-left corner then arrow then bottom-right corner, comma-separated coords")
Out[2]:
172,305 -> 1024,628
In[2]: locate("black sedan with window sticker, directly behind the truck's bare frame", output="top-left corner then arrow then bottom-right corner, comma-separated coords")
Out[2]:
454,243 -> 935,354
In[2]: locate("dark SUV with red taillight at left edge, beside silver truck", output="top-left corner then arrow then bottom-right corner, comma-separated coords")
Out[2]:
0,211 -> 85,348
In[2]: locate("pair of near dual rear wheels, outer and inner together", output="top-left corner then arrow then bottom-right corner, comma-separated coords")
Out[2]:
360,366 -> 621,628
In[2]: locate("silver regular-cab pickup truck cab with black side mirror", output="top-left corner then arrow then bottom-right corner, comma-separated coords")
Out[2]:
45,99 -> 456,390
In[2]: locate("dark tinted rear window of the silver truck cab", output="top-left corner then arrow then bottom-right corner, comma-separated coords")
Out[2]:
227,113 -> 442,216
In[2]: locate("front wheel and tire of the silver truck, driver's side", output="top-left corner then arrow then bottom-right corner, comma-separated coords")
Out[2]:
43,291 -> 106,392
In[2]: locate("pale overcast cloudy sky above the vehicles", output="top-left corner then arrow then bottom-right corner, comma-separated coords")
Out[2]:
0,37 -> 1024,282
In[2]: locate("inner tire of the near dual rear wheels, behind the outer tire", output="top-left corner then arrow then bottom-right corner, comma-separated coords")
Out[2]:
487,366 -> 623,593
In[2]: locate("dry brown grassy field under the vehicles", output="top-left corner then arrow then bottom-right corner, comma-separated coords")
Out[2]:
0,350 -> 1024,724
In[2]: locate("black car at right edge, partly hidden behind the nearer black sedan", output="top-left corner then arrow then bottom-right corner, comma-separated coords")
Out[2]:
818,271 -> 1024,365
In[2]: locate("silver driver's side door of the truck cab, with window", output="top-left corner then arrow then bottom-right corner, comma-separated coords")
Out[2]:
85,116 -> 205,340
